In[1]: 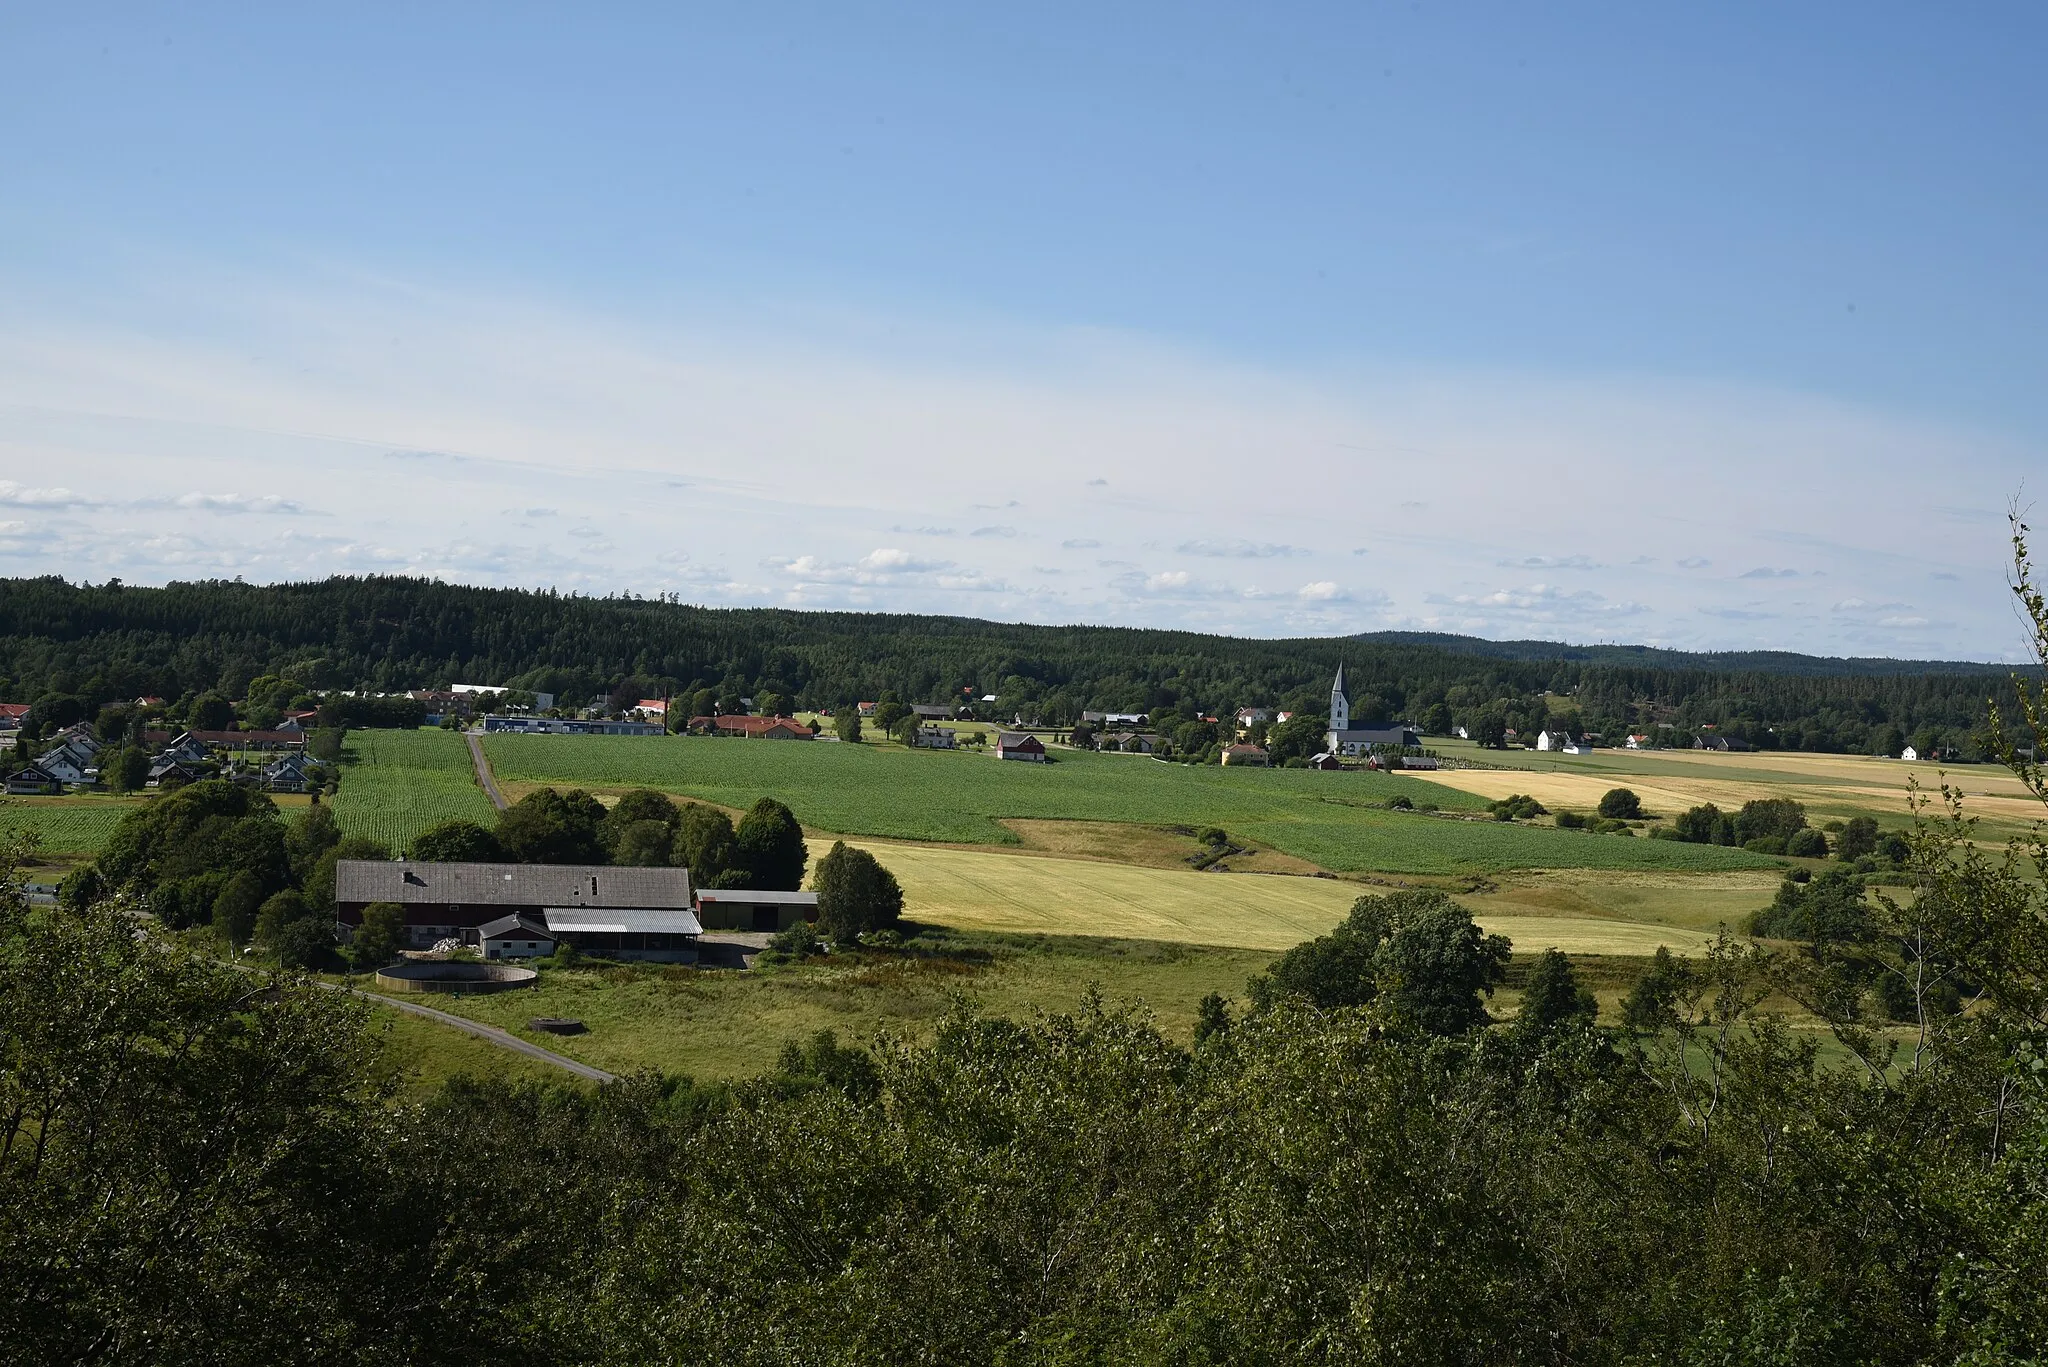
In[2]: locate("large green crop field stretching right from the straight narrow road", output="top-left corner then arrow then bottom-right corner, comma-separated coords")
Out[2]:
483,736 -> 1769,875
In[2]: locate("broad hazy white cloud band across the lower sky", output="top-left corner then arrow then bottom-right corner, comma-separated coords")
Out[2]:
0,268 -> 2034,658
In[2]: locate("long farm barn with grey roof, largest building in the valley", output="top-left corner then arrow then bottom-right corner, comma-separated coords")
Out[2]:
334,859 -> 698,957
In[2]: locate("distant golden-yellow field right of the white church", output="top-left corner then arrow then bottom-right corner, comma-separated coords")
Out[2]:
1413,742 -> 2042,828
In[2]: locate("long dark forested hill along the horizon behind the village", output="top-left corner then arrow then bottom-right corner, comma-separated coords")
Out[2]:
0,576 -> 2009,750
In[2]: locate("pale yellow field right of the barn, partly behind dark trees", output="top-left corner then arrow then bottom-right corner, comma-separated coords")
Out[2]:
811,840 -> 1720,955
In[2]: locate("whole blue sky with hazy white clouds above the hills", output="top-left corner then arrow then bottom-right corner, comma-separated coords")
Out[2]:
0,0 -> 2048,660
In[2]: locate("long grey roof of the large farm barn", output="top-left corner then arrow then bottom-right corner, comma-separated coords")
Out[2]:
334,859 -> 690,910
